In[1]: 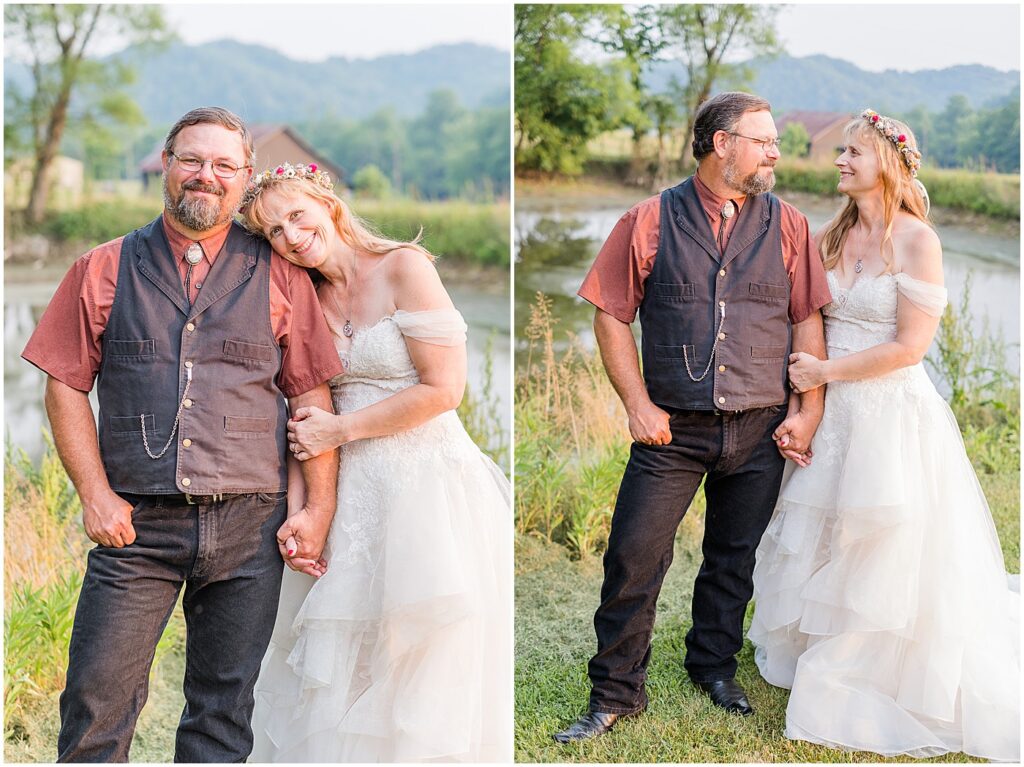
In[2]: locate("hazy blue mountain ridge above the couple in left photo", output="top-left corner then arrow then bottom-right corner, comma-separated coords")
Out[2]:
4,40 -> 510,125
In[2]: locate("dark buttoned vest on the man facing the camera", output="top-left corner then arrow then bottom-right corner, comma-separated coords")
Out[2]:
97,217 -> 288,495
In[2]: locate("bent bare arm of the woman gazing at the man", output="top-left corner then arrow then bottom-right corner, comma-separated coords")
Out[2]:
790,221 -> 943,391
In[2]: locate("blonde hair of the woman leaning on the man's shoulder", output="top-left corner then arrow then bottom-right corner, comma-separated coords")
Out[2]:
242,177 -> 435,261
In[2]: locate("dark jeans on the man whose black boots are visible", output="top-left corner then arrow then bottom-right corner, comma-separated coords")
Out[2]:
589,408 -> 785,714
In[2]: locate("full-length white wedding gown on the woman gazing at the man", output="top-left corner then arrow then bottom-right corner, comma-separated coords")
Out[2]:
749,272 -> 1020,762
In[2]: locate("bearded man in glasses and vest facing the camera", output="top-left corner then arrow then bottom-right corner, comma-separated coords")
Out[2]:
23,108 -> 341,762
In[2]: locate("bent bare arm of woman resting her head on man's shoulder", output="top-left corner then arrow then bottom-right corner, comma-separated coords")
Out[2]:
288,249 -> 466,460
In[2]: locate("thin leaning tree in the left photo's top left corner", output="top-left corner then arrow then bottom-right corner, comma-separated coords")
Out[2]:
4,4 -> 165,222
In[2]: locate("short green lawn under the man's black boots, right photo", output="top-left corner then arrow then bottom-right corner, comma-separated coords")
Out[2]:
515,515 -> 999,763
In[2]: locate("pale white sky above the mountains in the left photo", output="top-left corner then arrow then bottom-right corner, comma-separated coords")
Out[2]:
164,3 -> 512,61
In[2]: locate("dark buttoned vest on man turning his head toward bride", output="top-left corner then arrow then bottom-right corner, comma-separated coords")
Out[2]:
640,178 -> 792,411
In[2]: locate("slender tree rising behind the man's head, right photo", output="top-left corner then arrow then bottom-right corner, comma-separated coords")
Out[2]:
657,3 -> 778,165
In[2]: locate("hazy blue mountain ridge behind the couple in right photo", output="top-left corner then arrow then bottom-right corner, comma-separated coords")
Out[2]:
647,55 -> 1020,115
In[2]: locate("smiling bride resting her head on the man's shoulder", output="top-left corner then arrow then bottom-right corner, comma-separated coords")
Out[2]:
243,164 -> 512,762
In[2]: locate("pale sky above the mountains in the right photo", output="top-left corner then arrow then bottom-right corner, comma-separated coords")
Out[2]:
776,3 -> 1021,72
